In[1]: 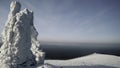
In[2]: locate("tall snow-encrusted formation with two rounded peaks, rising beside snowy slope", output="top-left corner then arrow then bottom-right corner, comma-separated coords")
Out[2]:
0,1 -> 44,68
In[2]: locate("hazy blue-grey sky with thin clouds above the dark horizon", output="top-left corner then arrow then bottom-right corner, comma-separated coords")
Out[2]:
0,0 -> 120,43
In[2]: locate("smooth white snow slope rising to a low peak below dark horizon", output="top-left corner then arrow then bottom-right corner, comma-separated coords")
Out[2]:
44,53 -> 120,68
